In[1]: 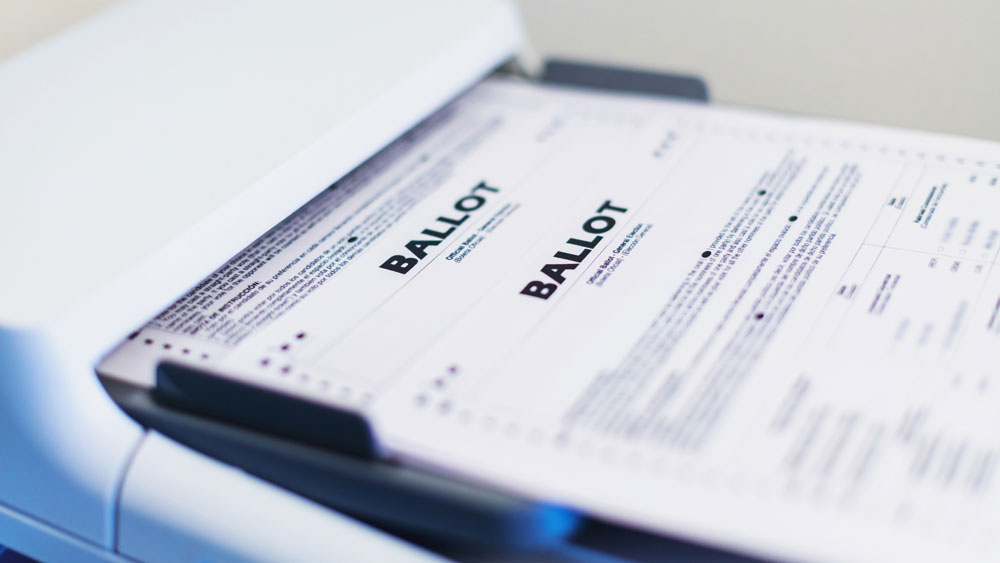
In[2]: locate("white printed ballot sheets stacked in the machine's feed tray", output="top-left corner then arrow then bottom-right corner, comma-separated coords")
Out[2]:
100,79 -> 1000,561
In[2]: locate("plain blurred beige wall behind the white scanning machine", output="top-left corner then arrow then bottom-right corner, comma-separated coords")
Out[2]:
0,0 -> 1000,140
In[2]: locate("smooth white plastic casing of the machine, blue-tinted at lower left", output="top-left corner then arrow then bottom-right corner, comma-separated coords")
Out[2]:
0,0 -> 520,560
